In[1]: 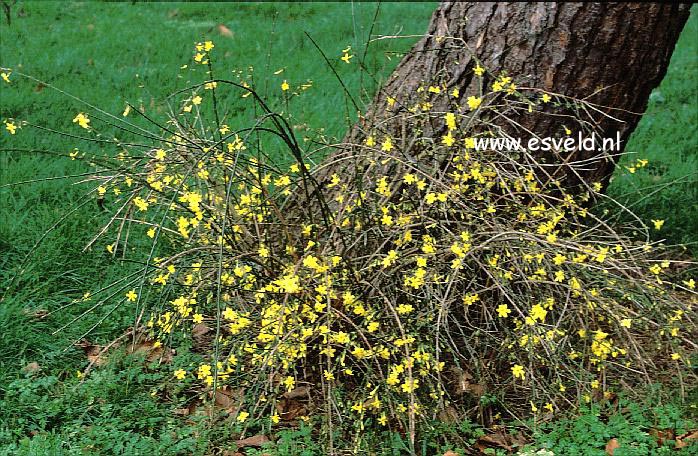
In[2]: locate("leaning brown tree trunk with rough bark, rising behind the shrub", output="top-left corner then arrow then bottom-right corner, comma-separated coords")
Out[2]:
327,2 -> 690,191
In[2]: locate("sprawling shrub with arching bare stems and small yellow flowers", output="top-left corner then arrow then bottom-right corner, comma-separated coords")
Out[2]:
2,43 -> 696,452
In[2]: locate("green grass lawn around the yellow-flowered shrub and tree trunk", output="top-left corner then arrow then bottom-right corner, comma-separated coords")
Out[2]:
0,2 -> 698,455
